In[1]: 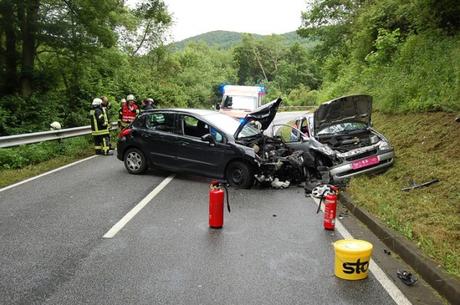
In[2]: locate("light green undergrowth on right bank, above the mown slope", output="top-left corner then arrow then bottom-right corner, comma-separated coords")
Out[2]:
319,32 -> 460,113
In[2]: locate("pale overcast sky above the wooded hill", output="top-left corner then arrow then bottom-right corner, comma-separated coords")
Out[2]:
160,0 -> 306,41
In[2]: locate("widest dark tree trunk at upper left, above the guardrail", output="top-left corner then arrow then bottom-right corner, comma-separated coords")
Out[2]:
18,0 -> 40,97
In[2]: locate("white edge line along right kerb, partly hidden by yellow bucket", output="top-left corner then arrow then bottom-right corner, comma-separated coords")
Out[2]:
312,197 -> 412,305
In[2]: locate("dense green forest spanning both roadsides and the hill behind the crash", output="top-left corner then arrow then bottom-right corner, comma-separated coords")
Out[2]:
0,0 -> 460,135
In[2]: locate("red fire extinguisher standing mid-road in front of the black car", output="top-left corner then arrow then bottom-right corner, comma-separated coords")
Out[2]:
209,181 -> 230,229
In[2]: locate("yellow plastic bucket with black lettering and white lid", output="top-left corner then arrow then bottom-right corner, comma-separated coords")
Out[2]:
334,239 -> 372,281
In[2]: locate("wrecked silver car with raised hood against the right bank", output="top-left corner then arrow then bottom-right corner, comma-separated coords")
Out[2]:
272,95 -> 394,183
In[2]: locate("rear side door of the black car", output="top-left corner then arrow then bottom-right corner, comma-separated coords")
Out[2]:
140,112 -> 180,169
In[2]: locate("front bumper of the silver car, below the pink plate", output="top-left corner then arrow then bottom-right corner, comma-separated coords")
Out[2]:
330,151 -> 394,181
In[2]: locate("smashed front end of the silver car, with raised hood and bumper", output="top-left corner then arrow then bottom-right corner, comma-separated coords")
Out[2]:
312,95 -> 394,182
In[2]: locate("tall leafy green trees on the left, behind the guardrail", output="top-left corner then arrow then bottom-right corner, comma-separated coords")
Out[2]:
0,0 -> 170,132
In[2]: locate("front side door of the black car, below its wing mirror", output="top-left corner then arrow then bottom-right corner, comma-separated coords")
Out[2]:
177,114 -> 235,178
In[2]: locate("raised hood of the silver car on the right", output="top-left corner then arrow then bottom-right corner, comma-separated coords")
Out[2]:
313,95 -> 372,134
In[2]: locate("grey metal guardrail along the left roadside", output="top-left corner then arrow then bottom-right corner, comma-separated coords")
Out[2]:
0,122 -> 117,148
